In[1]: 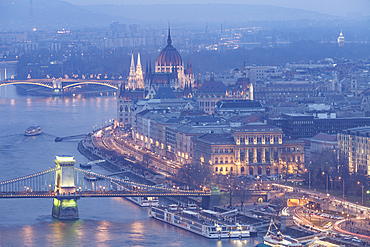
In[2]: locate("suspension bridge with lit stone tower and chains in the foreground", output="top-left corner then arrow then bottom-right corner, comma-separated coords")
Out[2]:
0,155 -> 211,219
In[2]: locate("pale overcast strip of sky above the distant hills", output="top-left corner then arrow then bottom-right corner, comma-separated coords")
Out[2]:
65,0 -> 370,16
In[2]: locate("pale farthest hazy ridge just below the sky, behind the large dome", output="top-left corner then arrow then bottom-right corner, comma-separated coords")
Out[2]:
81,4 -> 332,23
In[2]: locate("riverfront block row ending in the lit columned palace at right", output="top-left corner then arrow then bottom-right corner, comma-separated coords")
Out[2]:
132,102 -> 304,175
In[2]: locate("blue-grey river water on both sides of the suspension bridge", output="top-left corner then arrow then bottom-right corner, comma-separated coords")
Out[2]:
0,86 -> 261,247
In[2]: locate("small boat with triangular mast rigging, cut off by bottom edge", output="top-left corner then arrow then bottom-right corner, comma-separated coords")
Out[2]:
263,219 -> 302,247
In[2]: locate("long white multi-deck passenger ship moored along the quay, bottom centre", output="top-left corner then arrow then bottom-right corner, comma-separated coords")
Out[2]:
149,205 -> 257,239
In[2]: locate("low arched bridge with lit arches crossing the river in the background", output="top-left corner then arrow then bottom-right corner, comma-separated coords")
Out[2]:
0,78 -> 120,93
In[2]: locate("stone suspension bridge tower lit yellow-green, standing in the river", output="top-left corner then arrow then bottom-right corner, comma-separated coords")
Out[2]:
52,155 -> 79,220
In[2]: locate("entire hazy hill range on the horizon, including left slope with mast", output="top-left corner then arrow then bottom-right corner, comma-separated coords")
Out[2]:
0,0 -> 333,31
